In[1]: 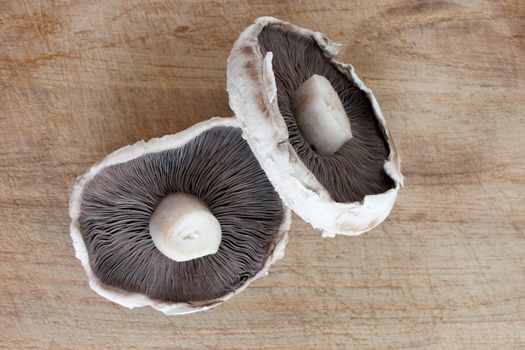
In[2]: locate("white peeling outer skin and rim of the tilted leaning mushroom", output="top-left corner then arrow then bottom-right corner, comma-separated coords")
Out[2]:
227,17 -> 403,237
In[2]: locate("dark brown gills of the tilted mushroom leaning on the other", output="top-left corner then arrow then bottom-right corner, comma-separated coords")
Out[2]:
258,24 -> 395,203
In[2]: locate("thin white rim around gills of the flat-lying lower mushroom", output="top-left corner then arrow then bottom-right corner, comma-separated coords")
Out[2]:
69,117 -> 291,315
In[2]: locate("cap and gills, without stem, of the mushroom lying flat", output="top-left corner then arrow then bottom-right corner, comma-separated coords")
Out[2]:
69,118 -> 290,315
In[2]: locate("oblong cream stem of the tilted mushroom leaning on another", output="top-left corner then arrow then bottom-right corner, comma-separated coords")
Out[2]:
292,74 -> 352,155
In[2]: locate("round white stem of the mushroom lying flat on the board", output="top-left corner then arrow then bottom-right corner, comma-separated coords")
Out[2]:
149,193 -> 222,261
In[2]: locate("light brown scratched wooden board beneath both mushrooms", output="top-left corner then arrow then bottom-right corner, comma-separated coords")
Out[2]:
0,0 -> 525,349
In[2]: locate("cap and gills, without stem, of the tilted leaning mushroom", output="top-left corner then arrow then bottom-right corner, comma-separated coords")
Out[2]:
227,17 -> 403,237
